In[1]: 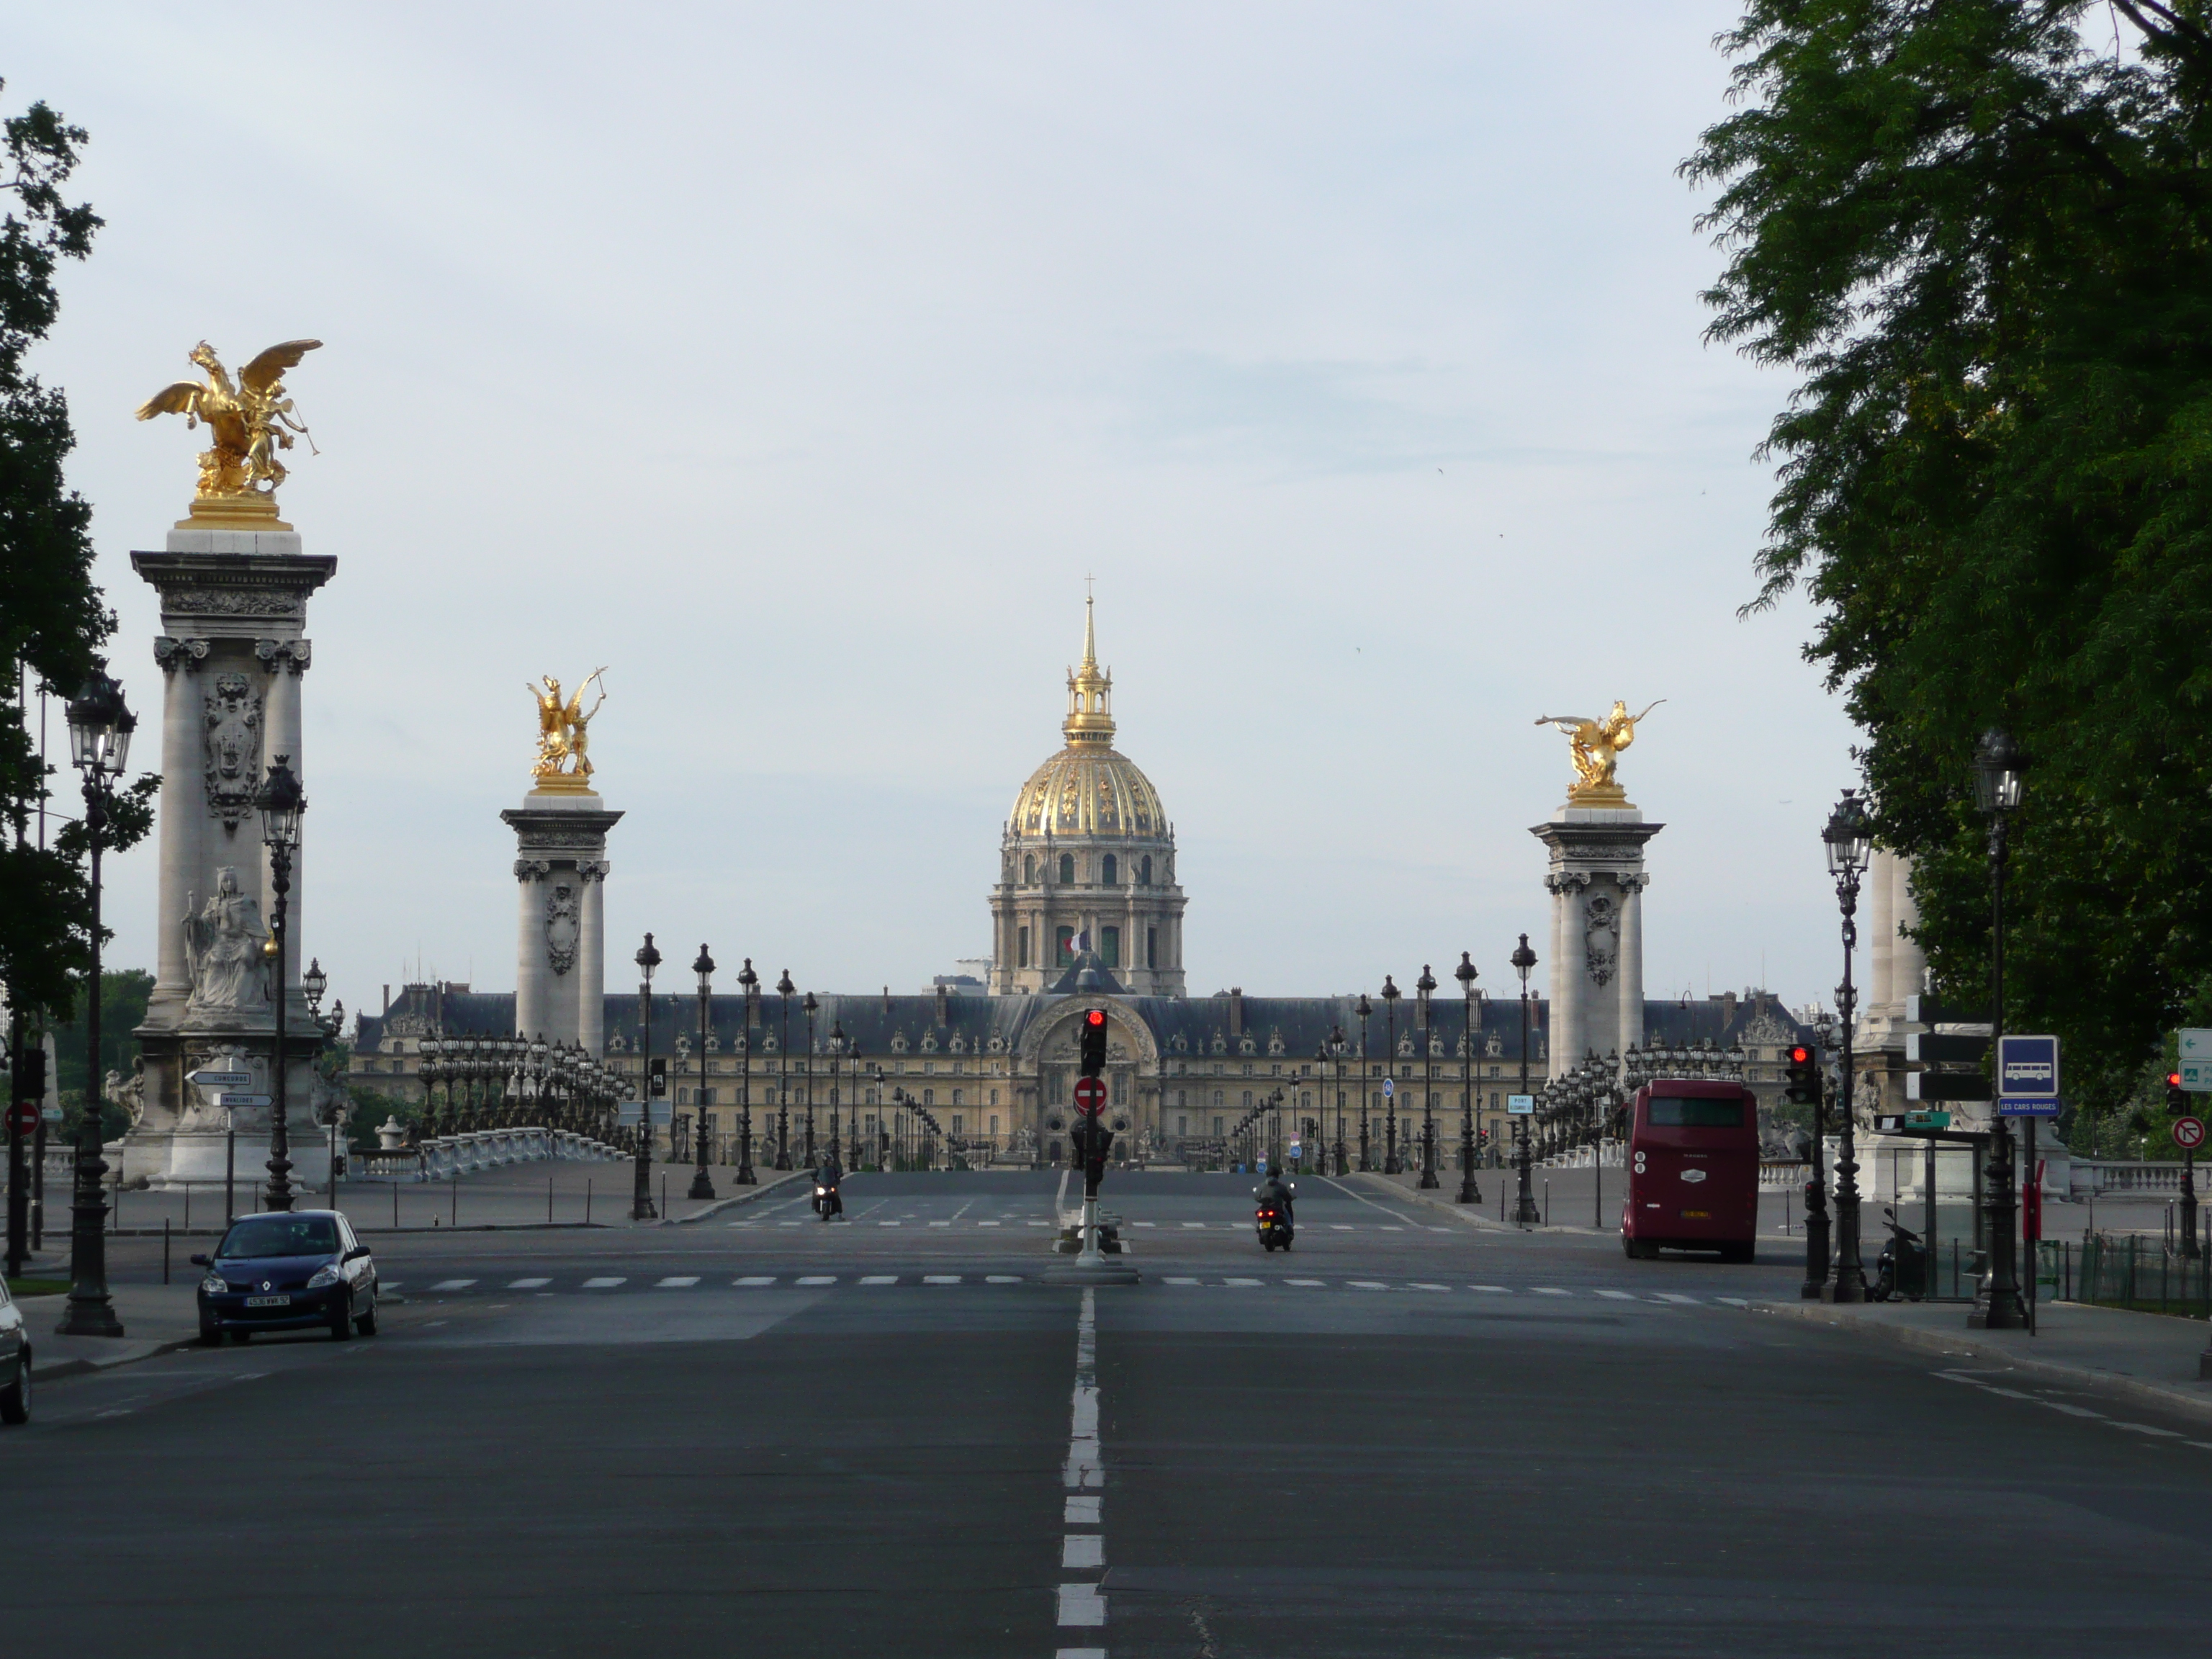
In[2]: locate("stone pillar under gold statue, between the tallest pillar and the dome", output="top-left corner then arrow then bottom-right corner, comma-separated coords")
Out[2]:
500,788 -> 621,1055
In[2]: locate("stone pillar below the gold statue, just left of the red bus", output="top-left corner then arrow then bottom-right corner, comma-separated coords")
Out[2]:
1529,801 -> 1665,1077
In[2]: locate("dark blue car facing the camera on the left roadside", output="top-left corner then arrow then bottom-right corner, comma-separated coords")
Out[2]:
192,1210 -> 376,1343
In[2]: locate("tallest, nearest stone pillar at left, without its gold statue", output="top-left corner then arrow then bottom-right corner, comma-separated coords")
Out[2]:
122,518 -> 338,1188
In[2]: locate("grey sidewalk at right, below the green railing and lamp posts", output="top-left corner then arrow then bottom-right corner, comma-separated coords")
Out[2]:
1752,1300 -> 2212,1418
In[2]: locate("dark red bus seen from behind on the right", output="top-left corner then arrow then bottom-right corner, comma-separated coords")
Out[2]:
1622,1077 -> 1758,1261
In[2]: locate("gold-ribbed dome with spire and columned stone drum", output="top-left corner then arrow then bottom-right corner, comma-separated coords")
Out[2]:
991,600 -> 1184,997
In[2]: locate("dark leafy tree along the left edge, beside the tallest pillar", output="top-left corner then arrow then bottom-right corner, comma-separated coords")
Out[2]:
0,82 -> 155,1013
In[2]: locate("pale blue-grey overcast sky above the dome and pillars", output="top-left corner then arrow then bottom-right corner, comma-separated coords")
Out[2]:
13,0 -> 1851,1026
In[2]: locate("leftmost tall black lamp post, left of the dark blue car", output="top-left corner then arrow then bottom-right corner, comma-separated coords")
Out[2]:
57,659 -> 137,1336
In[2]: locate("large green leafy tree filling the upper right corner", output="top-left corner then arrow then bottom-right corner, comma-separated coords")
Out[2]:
1683,0 -> 2212,1119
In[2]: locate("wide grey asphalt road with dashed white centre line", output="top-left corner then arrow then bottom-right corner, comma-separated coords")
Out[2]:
0,1174 -> 2212,1659
